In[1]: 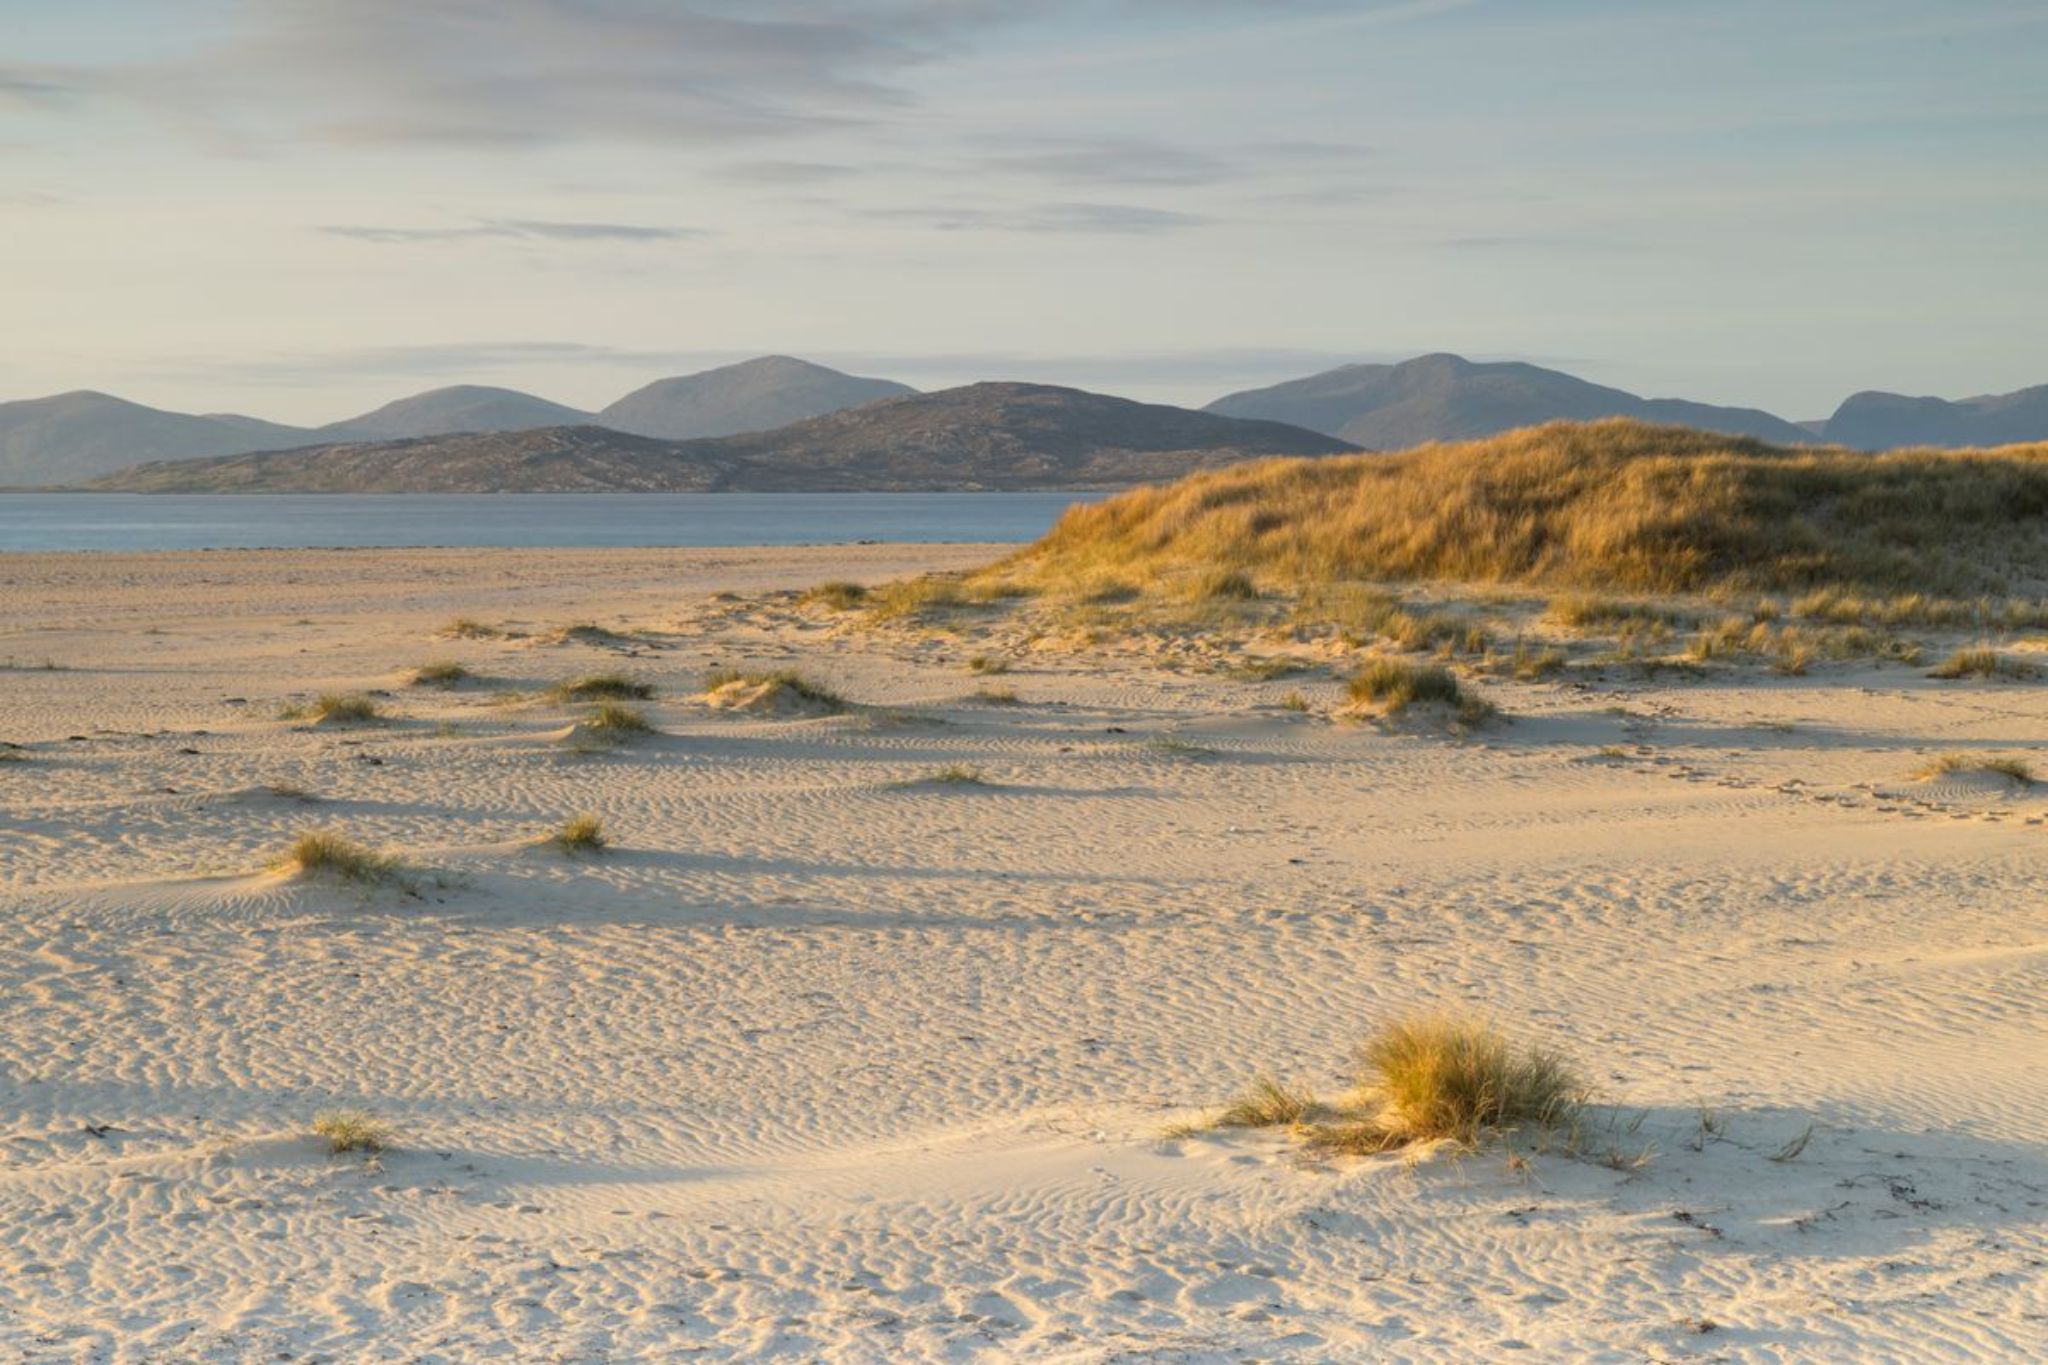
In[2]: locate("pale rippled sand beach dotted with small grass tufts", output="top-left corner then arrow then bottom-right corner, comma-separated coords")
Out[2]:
0,546 -> 2048,1363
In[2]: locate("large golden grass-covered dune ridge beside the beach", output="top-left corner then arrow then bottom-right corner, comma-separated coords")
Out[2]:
983,420 -> 2048,598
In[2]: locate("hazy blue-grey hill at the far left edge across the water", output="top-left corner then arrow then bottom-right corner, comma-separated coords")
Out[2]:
0,389 -> 307,485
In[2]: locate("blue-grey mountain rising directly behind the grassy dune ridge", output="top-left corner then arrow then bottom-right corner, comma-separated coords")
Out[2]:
1206,354 -> 1812,450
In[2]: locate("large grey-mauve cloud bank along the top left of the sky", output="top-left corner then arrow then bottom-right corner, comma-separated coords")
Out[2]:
0,0 -> 995,147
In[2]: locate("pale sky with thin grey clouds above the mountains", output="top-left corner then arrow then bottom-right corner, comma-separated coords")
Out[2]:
0,0 -> 2048,422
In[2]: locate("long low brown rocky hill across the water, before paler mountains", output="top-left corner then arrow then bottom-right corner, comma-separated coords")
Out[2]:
92,385 -> 1352,493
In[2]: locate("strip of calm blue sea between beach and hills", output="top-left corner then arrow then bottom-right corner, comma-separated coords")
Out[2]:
0,493 -> 1100,551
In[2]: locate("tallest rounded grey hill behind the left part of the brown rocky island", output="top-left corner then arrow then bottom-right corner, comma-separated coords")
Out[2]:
598,356 -> 915,440
